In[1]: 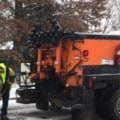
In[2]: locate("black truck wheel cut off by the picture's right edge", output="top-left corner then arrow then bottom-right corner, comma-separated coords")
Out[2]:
109,89 -> 120,120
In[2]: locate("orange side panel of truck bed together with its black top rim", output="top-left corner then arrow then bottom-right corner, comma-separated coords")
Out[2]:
71,33 -> 120,65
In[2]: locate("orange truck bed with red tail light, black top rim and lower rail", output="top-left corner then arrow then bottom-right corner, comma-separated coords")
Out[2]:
57,33 -> 120,86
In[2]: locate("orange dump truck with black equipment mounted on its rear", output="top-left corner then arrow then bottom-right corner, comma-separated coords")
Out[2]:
16,19 -> 120,120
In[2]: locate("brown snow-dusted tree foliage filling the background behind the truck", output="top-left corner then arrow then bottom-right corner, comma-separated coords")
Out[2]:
0,0 -> 108,68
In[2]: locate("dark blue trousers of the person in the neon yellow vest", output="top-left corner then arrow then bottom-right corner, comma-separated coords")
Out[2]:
1,88 -> 10,116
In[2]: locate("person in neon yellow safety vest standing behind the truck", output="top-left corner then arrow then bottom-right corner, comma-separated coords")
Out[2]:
0,62 -> 15,120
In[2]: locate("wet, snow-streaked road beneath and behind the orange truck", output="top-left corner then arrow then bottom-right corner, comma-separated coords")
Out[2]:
0,85 -> 101,120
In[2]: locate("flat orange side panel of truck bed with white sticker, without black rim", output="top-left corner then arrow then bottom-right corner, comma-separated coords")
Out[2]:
82,39 -> 120,65
